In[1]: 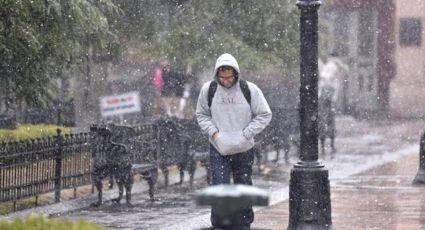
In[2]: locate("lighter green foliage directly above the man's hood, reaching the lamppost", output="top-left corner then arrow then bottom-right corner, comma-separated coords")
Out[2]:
120,0 -> 299,75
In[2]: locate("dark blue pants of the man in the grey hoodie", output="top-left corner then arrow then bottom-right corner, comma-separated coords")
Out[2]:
210,145 -> 254,227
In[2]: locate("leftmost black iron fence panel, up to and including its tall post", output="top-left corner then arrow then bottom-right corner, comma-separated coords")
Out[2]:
0,137 -> 57,202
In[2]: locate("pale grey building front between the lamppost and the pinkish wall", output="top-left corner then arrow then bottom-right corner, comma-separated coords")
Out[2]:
323,0 -> 397,116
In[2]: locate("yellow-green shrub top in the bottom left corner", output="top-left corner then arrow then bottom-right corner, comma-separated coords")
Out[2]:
0,215 -> 105,230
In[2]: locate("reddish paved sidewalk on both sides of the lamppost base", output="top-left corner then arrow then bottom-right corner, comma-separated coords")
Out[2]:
252,140 -> 425,230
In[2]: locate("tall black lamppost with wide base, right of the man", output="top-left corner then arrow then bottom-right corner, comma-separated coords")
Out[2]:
288,0 -> 332,229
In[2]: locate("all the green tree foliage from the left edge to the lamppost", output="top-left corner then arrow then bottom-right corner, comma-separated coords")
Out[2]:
0,0 -> 299,114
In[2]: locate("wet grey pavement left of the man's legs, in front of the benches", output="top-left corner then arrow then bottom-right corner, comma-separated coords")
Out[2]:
60,178 -> 208,229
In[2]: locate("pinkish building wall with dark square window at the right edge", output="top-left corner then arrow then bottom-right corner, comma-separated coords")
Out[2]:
390,0 -> 425,118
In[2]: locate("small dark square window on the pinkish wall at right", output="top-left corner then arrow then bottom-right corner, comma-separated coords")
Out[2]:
400,18 -> 422,46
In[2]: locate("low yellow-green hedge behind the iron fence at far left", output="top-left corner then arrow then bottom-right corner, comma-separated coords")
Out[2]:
0,124 -> 70,142
